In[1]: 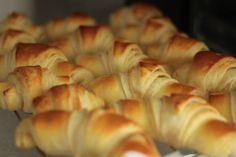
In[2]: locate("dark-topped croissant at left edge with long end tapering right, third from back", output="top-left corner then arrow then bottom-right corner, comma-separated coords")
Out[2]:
0,43 -> 93,83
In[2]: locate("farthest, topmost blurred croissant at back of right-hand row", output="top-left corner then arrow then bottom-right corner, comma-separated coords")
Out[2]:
110,3 -> 162,34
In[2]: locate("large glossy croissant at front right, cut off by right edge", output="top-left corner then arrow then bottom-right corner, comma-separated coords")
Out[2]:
114,94 -> 236,156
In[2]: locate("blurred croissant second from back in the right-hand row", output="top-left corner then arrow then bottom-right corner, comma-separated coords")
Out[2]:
116,17 -> 177,44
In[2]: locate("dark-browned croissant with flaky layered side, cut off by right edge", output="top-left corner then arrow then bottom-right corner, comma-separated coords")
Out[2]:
175,51 -> 236,95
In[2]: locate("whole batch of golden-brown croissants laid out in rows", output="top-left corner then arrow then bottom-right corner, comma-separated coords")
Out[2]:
0,3 -> 236,157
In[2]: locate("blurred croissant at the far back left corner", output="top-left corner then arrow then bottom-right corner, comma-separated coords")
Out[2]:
0,12 -> 47,42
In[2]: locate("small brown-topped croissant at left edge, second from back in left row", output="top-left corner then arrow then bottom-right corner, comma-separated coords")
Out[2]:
0,29 -> 36,55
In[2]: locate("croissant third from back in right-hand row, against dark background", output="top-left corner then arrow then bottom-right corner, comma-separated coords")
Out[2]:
146,33 -> 208,68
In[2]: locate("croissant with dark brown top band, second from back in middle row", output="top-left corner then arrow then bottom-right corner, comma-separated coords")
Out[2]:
50,25 -> 113,60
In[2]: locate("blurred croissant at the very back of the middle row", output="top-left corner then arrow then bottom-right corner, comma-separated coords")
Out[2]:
45,13 -> 96,41
